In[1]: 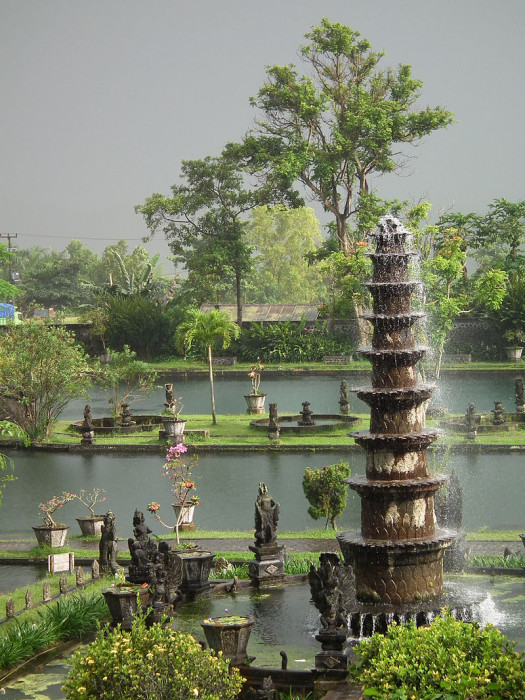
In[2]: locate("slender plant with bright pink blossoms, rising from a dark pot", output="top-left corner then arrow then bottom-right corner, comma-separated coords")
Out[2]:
148,442 -> 200,544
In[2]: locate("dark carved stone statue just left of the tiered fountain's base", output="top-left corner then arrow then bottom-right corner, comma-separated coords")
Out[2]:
308,552 -> 348,632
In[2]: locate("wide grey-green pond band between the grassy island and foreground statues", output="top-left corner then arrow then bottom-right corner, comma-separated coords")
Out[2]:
0,449 -> 525,539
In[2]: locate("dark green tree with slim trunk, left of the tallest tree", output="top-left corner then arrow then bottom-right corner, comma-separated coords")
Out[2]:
135,156 -> 268,324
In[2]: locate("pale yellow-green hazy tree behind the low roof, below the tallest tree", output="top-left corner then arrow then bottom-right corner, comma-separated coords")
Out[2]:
248,205 -> 325,303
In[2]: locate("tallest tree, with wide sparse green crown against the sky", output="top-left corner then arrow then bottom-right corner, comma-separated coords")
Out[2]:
228,18 -> 453,254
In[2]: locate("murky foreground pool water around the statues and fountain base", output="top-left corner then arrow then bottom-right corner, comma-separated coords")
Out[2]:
5,576 -> 525,700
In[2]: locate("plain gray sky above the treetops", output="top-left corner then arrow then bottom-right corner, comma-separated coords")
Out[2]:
0,0 -> 525,271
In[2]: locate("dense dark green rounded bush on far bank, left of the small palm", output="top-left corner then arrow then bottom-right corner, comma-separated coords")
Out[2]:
103,294 -> 173,360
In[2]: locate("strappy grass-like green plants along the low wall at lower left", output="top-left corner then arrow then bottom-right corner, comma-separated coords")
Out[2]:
0,594 -> 108,669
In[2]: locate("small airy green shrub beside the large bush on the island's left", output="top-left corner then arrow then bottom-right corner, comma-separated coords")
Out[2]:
96,345 -> 157,416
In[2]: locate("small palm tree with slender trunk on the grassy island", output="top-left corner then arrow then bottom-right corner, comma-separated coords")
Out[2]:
175,309 -> 240,425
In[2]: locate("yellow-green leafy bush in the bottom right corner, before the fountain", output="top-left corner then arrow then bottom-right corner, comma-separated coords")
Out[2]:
353,611 -> 525,700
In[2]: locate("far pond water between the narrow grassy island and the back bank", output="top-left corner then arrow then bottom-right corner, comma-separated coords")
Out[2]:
62,367 -> 525,420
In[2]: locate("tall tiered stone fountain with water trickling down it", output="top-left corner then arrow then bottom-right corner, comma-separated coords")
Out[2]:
338,216 -> 460,636
